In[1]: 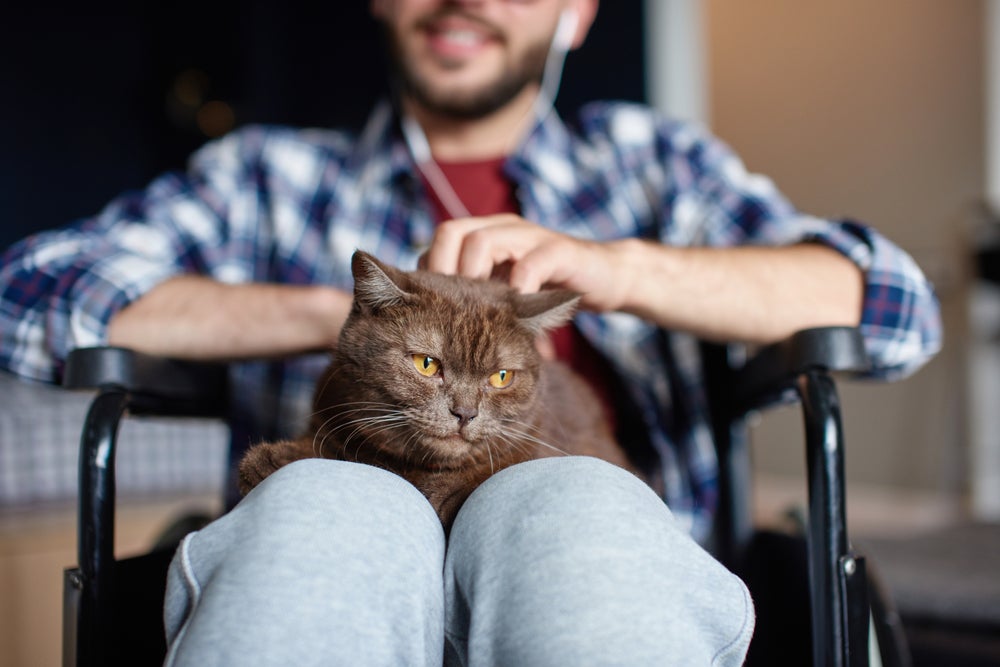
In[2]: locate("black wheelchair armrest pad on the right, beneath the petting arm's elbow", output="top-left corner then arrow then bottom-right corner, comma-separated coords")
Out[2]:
728,326 -> 871,416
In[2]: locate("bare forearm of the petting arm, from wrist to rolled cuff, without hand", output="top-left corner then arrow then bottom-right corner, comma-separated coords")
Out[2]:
621,240 -> 864,343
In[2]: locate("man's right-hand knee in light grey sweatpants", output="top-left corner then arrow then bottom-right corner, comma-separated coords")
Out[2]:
445,458 -> 753,664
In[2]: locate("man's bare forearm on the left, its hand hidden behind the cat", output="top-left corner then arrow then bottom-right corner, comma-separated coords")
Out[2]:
108,276 -> 351,359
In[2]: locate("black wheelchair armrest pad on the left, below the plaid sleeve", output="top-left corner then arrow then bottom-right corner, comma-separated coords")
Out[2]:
62,347 -> 228,417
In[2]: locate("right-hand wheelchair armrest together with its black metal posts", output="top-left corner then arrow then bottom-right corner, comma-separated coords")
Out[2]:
703,327 -> 869,667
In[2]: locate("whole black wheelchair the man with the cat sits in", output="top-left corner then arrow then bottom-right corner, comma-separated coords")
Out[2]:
63,327 -> 909,667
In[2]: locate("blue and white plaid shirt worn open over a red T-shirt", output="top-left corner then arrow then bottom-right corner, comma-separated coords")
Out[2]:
0,103 -> 941,539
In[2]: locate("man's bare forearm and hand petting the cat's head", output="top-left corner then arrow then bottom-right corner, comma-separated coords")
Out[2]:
424,215 -> 864,343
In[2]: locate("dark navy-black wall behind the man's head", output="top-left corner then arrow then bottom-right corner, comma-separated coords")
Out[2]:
0,0 -> 644,248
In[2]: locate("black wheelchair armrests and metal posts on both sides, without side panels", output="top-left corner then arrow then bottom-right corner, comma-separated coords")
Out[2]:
63,327 -> 884,667
